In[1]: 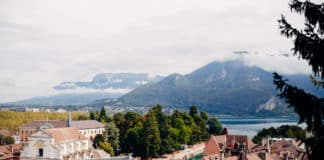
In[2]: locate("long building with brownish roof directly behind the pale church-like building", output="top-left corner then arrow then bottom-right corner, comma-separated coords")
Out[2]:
19,113 -> 105,143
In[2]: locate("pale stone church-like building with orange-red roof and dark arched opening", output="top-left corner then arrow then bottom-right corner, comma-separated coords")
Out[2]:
21,127 -> 95,160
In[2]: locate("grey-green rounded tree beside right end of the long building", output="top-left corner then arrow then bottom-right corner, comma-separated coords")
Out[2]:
105,122 -> 119,154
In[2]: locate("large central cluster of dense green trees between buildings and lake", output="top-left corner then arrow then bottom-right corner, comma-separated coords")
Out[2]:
113,105 -> 218,158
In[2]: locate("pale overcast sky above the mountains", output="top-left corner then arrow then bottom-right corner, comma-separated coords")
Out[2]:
0,0 -> 311,103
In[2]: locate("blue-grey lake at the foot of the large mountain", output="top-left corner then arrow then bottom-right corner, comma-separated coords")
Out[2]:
219,118 -> 306,138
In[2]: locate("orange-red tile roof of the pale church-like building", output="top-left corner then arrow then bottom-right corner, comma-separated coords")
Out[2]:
44,128 -> 86,144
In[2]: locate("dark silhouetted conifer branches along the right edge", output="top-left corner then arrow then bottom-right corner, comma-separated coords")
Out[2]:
273,0 -> 324,160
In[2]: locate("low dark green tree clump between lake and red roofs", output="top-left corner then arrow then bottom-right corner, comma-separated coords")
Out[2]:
252,125 -> 306,144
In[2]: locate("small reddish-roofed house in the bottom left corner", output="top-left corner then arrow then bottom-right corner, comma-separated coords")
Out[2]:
0,144 -> 22,160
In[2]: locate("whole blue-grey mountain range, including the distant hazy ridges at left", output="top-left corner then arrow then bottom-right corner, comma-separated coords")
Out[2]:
5,60 -> 324,116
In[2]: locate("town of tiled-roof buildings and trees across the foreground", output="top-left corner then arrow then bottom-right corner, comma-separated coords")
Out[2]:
0,105 -> 306,160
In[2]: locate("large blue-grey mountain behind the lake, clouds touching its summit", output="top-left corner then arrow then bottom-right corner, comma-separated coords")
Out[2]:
109,60 -> 324,115
